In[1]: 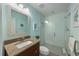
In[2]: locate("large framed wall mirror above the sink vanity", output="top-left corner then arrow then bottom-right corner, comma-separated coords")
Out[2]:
8,6 -> 31,35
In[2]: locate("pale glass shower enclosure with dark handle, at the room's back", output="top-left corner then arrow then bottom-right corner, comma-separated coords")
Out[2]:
45,14 -> 65,47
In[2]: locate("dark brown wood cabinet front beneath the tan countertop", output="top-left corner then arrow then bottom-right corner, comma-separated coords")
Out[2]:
16,42 -> 39,56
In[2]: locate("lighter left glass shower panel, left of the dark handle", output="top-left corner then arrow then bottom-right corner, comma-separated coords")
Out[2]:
45,17 -> 55,45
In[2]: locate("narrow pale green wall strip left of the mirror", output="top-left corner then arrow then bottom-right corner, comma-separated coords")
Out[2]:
0,4 -> 8,55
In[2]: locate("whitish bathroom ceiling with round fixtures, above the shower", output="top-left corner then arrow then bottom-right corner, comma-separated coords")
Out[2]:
31,3 -> 70,16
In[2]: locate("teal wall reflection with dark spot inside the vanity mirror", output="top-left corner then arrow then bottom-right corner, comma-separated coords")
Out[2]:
11,10 -> 28,33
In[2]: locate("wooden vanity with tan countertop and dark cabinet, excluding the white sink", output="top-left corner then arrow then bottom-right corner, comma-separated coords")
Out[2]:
4,37 -> 40,56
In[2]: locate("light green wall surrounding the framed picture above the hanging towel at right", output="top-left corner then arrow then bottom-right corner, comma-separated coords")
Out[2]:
68,3 -> 79,39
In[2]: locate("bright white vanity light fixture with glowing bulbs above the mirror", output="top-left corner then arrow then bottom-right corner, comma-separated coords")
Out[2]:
8,3 -> 32,17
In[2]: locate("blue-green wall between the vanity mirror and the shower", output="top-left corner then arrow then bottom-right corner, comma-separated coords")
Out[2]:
24,4 -> 45,36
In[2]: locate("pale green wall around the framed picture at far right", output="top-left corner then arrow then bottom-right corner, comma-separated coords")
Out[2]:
70,4 -> 79,40
